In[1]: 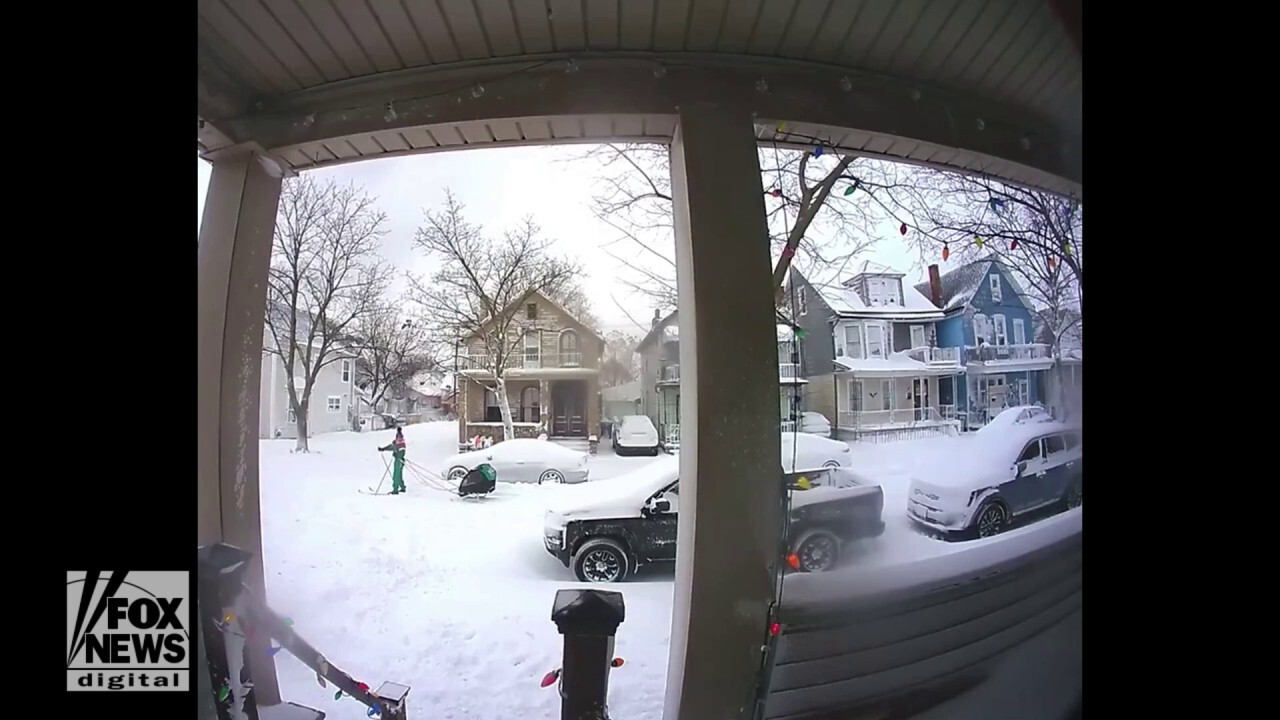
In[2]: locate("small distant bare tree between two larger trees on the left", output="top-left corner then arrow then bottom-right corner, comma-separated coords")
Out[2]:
356,302 -> 442,410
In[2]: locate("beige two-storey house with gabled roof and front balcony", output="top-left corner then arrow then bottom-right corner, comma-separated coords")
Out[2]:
454,292 -> 604,442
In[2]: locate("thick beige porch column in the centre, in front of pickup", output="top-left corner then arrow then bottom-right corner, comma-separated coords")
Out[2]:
663,105 -> 782,720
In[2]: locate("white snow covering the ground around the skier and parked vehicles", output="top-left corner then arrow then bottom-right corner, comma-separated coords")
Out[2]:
261,421 -> 1039,720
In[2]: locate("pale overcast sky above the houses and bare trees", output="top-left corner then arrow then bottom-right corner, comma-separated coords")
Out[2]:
196,146 -> 924,332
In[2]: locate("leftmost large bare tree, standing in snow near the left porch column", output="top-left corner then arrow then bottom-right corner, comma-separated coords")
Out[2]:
265,177 -> 389,452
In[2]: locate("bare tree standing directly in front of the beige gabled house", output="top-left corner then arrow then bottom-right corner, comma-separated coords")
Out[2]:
410,191 -> 579,439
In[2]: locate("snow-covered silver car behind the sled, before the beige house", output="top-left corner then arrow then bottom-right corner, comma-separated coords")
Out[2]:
443,438 -> 590,484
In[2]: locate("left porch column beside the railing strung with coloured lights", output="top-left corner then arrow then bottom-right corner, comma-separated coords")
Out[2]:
196,146 -> 283,705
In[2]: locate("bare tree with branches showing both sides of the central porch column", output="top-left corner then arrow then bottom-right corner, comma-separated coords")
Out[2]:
585,139 -> 887,310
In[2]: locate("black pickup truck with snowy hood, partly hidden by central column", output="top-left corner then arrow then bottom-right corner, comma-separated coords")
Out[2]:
543,457 -> 884,583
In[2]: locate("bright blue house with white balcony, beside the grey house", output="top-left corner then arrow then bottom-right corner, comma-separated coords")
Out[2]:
915,258 -> 1053,429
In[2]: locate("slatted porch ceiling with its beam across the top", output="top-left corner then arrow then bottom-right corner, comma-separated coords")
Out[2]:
197,0 -> 1082,193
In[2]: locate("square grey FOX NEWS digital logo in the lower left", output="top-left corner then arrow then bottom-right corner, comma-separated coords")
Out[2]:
67,570 -> 191,692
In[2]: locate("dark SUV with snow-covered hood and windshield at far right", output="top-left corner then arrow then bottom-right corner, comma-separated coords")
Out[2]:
906,417 -> 1084,538
